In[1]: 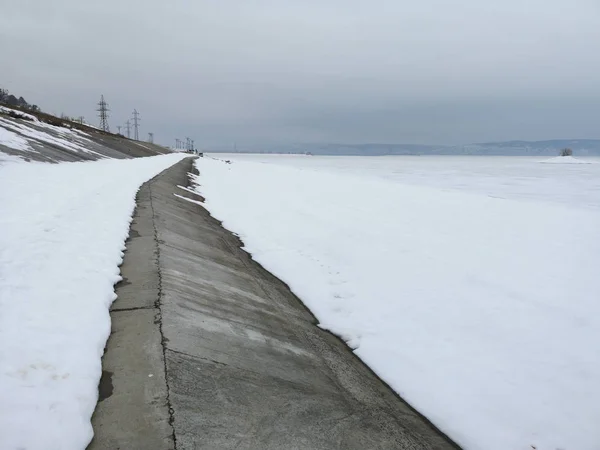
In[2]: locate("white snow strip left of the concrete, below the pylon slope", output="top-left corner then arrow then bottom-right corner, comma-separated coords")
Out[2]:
0,155 -> 188,450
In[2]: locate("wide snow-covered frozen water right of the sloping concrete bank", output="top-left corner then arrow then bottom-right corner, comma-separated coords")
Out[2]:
196,155 -> 600,450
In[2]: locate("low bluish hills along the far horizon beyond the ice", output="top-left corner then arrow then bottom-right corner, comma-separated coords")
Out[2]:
210,139 -> 600,156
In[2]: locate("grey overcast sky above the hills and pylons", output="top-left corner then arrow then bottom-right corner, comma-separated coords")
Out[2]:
0,0 -> 600,148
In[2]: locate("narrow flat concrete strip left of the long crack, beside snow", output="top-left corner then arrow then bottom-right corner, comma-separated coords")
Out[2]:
88,183 -> 175,450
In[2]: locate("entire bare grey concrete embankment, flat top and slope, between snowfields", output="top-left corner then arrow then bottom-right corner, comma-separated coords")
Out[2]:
89,159 -> 457,450
